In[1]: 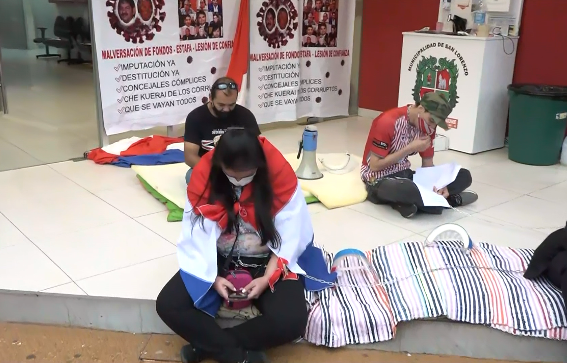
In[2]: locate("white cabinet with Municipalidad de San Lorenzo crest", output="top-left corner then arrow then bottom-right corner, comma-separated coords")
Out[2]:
398,32 -> 520,154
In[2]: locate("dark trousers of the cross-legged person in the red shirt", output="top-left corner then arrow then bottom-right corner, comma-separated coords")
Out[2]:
366,169 -> 472,214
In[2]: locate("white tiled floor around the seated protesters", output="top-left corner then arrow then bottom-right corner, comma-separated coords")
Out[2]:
0,118 -> 567,299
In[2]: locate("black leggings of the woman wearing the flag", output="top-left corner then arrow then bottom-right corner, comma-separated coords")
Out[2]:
156,272 -> 308,362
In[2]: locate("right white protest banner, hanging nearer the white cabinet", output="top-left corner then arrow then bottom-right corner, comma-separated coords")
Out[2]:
248,0 -> 355,123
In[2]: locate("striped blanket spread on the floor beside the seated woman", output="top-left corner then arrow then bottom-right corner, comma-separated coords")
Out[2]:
305,242 -> 567,347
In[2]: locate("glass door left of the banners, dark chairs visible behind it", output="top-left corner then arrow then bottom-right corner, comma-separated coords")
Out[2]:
0,0 -> 99,171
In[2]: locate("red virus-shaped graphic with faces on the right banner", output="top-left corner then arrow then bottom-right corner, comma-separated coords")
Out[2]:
256,0 -> 299,49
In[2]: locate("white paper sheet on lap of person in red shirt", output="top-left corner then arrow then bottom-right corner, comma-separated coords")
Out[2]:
413,163 -> 461,208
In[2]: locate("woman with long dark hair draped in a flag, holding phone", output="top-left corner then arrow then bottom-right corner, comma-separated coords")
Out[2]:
156,129 -> 336,363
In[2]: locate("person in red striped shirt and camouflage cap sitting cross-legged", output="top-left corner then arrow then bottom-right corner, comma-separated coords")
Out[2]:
360,92 -> 478,218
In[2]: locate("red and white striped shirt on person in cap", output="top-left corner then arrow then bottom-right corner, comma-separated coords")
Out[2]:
360,107 -> 435,183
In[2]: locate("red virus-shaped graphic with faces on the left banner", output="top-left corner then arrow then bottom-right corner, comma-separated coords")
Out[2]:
106,0 -> 166,44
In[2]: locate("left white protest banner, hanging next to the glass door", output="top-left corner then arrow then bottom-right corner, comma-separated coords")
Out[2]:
91,0 -> 240,135
